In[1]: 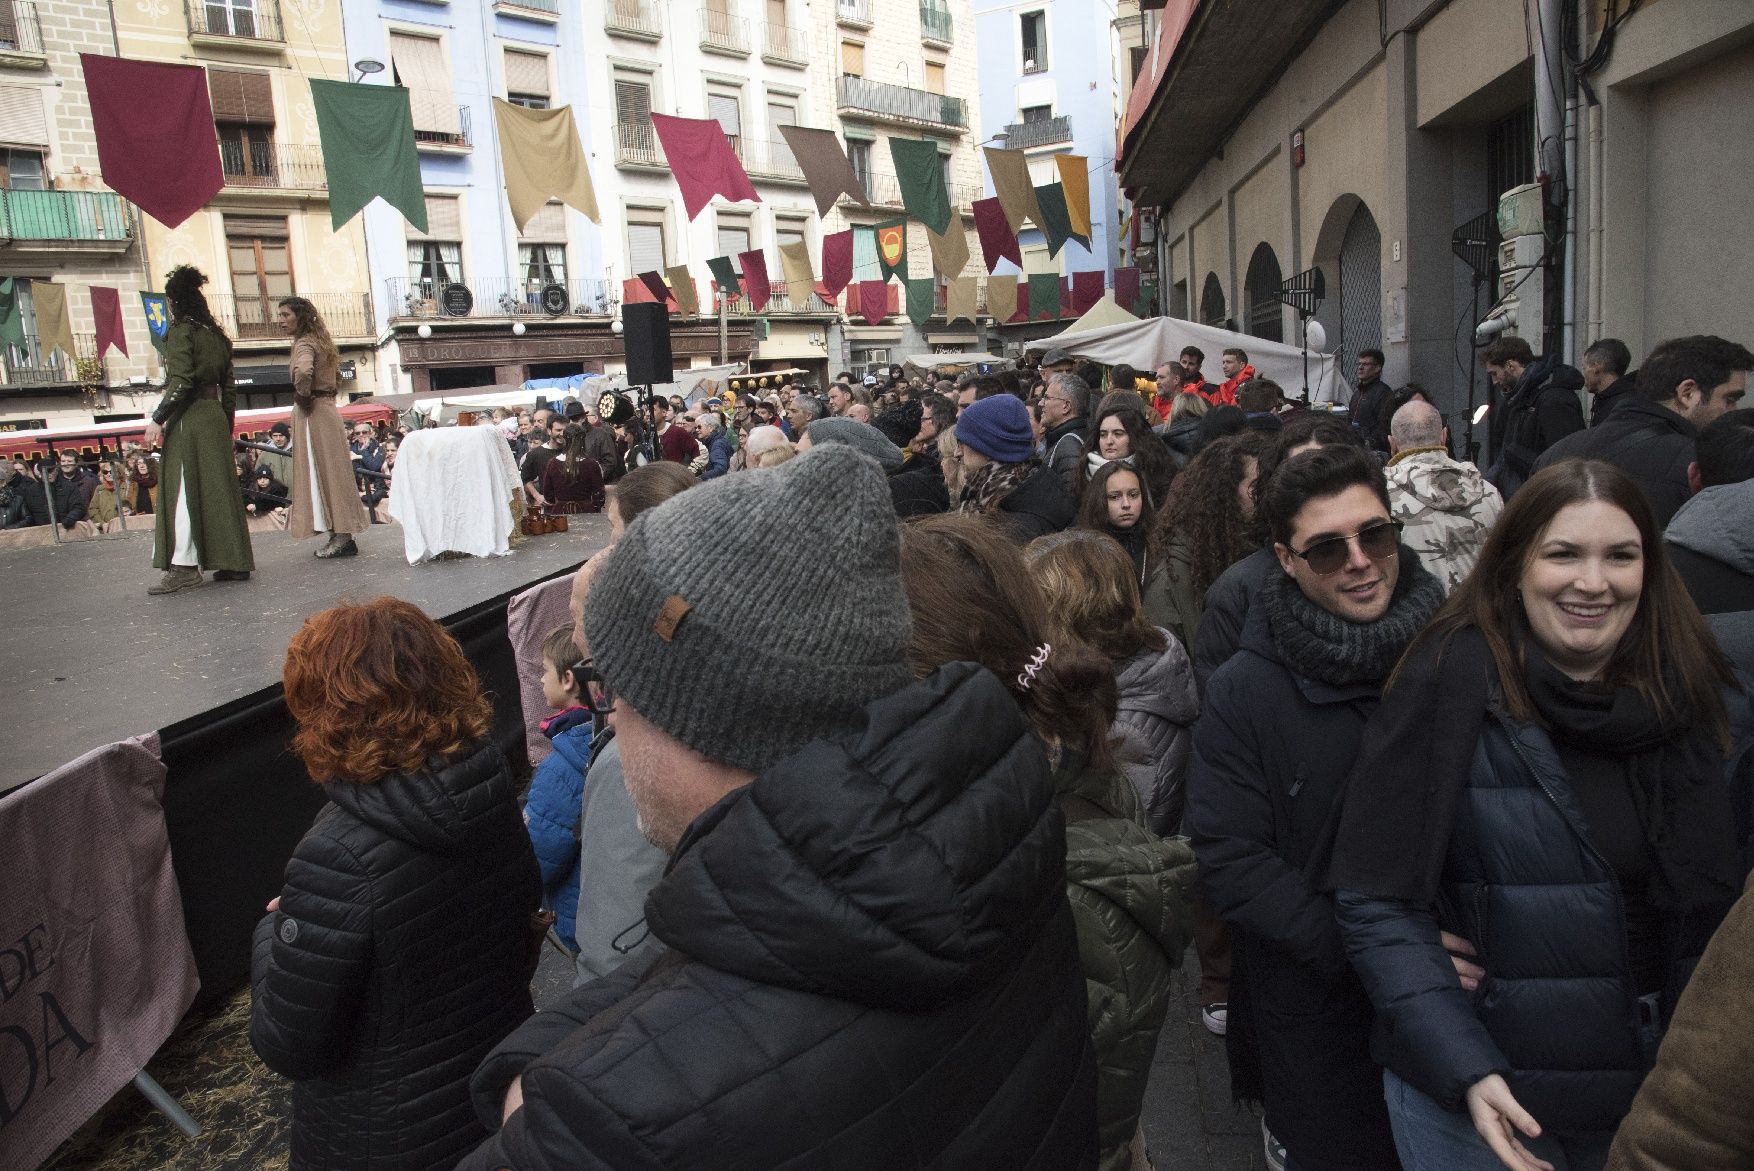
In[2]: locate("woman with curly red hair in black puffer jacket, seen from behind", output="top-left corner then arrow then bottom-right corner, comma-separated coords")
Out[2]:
249,598 -> 542,1171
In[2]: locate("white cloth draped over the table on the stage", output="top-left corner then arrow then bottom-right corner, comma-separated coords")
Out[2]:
389,428 -> 519,564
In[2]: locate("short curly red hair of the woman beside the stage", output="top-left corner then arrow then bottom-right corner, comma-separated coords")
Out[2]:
281,598 -> 493,785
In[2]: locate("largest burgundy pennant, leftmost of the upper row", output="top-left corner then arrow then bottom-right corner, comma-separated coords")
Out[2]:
82,53 -> 225,228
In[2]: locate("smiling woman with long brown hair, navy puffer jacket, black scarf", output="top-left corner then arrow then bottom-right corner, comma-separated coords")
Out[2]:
1330,459 -> 1754,1171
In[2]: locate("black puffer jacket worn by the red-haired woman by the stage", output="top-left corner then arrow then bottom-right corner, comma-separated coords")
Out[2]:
249,745 -> 542,1171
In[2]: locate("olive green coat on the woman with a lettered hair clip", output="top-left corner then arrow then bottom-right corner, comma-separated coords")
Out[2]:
1054,754 -> 1194,1171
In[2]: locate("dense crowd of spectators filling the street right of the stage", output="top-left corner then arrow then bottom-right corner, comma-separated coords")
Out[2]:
236,317 -> 1754,1171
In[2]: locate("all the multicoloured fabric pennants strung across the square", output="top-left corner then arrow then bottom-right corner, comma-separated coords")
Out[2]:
61,53 -> 1156,347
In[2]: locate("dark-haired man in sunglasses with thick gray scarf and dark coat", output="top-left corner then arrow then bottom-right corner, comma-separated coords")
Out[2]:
1182,445 -> 1438,1171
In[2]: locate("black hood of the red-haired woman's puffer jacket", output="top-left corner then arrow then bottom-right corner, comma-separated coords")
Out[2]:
323,743 -> 512,855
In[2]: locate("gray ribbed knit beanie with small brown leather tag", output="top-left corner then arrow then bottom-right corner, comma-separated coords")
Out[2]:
584,436 -> 912,771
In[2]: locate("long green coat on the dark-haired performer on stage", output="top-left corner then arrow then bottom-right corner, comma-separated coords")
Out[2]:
153,319 -> 256,573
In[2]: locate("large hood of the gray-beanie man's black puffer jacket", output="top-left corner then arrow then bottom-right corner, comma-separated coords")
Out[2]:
645,663 -> 1065,1011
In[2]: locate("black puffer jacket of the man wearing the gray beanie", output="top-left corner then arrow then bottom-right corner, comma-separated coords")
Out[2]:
461,663 -> 1096,1171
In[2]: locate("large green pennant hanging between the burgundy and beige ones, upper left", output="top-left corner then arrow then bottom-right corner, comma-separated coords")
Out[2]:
310,77 -> 427,231
